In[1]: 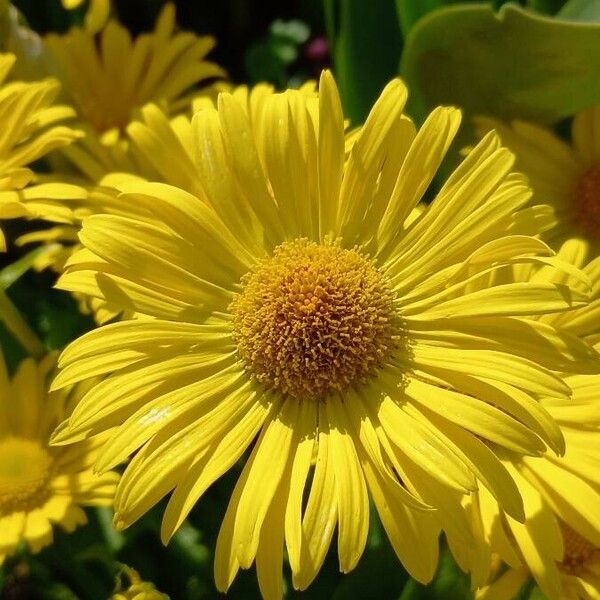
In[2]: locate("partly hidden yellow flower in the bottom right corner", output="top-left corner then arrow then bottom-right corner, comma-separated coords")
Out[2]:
475,432 -> 600,600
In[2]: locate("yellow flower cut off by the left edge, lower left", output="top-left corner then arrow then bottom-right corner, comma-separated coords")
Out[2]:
0,355 -> 118,563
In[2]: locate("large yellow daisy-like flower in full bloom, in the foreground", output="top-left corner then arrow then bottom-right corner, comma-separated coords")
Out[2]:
53,72 -> 597,598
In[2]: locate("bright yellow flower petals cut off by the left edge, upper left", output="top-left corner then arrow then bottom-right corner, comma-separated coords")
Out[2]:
0,54 -> 81,250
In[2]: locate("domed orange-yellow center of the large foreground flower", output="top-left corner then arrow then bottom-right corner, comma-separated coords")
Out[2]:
230,239 -> 399,400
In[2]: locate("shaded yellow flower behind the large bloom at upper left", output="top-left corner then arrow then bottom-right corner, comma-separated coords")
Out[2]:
45,3 -> 225,182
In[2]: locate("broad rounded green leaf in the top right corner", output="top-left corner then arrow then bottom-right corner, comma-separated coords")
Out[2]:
401,4 -> 600,123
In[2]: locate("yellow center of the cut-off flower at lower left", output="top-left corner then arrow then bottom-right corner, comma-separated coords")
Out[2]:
0,437 -> 52,516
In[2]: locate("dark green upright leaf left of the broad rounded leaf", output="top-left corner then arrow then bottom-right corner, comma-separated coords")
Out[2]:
325,0 -> 402,125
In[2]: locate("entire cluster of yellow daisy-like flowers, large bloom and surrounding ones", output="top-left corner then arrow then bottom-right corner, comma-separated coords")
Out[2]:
0,0 -> 600,600
